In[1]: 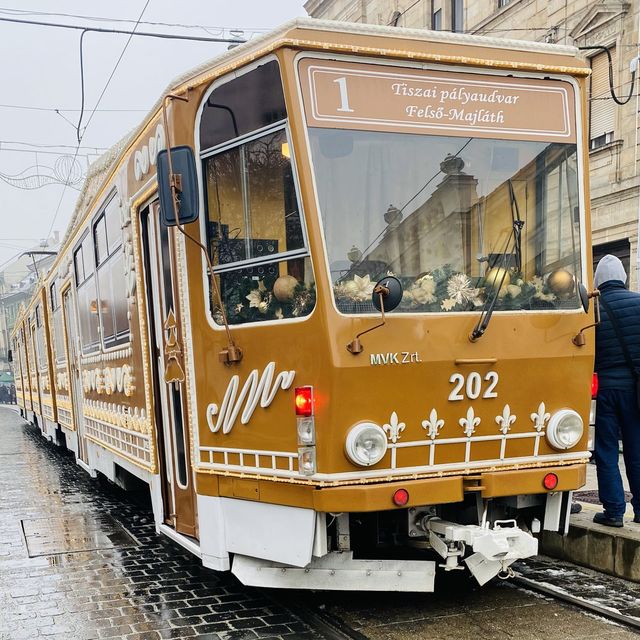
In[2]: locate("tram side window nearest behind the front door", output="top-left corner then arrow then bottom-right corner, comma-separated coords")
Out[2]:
93,198 -> 129,347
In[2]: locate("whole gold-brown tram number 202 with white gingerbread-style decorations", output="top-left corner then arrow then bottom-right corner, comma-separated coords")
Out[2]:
12,20 -> 594,591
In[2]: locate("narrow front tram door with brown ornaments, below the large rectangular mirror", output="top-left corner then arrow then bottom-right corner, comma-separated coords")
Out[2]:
141,201 -> 197,537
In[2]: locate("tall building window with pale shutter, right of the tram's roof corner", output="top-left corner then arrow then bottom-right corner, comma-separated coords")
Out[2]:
589,47 -> 615,150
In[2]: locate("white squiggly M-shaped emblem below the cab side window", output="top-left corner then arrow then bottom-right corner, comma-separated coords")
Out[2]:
207,362 -> 296,434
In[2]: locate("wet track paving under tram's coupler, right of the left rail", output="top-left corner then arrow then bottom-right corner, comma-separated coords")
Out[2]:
308,561 -> 640,640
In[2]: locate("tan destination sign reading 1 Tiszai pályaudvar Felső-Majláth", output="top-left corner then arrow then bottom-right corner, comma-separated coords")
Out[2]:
299,58 -> 575,142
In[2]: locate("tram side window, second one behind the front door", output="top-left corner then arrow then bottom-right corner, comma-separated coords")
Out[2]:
73,234 -> 100,353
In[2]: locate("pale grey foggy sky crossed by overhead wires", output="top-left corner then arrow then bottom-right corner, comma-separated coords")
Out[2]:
0,0 -> 306,270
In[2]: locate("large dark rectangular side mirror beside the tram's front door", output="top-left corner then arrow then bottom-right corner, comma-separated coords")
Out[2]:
156,146 -> 198,227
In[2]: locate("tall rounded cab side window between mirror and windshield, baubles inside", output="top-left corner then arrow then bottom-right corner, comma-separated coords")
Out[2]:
200,61 -> 315,324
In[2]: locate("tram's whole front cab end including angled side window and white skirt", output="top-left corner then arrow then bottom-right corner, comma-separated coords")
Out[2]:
184,22 -> 594,591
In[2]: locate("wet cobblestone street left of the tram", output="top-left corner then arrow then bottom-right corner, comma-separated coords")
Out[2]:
0,408 -> 321,640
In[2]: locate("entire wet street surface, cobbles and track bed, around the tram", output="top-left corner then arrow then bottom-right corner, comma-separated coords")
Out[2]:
0,408 -> 640,640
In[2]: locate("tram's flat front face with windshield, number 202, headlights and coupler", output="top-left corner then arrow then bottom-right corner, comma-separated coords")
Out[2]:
282,57 -> 593,583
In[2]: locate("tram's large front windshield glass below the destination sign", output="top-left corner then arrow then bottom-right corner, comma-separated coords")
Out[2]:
309,127 -> 582,314
